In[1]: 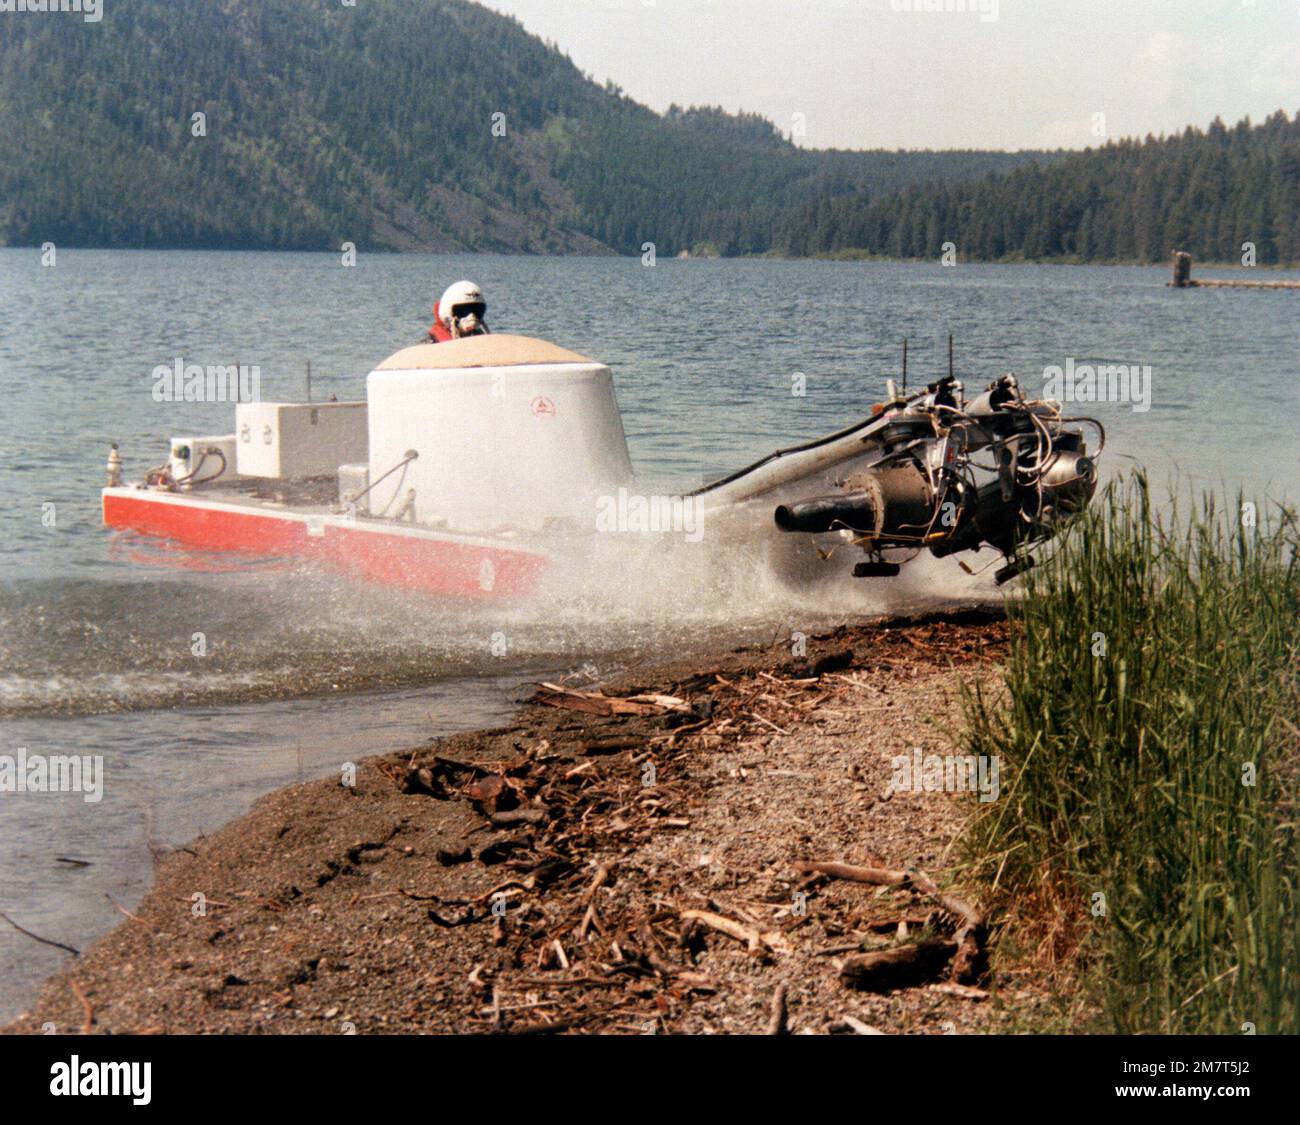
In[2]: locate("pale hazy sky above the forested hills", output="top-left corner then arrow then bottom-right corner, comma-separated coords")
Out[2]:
482,0 -> 1300,148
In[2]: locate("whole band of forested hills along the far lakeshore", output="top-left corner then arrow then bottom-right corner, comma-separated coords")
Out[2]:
0,0 -> 1284,263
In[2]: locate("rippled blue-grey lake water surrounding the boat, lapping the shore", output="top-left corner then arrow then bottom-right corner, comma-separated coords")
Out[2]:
0,250 -> 1300,1018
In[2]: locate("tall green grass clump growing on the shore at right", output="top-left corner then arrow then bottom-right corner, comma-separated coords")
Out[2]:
966,473 -> 1300,1034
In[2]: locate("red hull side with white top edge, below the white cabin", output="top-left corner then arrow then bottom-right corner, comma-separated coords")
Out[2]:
104,488 -> 550,598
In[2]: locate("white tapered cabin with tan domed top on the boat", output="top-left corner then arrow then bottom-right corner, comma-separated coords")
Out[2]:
367,336 -> 632,533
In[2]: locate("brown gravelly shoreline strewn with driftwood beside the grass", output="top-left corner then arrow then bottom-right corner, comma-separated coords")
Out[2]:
5,610 -> 1044,1034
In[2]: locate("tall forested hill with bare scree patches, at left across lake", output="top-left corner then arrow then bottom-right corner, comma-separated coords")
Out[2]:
0,0 -> 1032,254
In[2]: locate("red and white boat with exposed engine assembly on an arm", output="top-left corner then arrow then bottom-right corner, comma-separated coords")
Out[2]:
103,334 -> 1105,600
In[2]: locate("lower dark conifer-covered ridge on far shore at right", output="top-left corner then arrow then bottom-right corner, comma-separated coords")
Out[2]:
775,111 -> 1300,263
